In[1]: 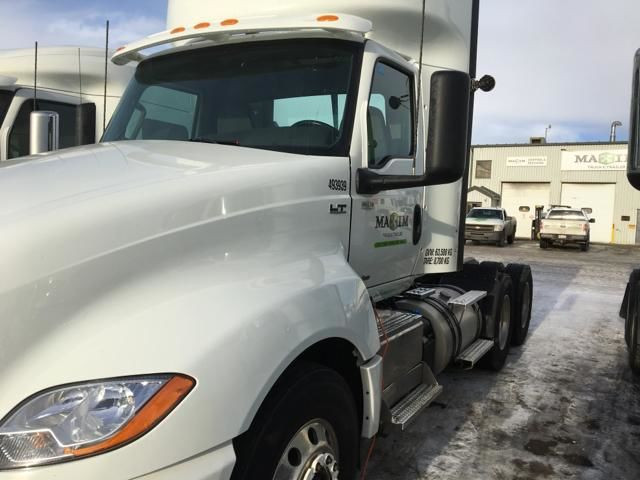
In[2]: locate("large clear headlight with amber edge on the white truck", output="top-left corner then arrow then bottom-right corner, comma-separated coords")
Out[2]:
0,375 -> 195,470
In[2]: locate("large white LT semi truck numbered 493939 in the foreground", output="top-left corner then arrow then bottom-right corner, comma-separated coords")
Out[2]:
0,0 -> 532,480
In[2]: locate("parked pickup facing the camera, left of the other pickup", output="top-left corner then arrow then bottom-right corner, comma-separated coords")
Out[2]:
464,208 -> 517,247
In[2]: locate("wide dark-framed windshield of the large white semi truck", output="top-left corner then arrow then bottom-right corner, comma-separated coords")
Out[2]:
103,39 -> 362,156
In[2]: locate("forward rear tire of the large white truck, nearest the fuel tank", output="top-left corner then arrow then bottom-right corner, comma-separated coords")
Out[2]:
481,275 -> 513,372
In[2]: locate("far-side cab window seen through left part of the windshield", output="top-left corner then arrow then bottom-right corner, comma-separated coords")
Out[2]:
125,85 -> 198,140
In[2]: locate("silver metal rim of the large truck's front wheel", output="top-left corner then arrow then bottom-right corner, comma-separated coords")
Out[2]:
273,418 -> 340,480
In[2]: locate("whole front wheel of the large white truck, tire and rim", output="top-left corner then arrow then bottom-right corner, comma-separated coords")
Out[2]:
231,363 -> 359,480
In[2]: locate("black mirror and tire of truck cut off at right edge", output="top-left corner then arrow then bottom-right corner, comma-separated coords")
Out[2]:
620,50 -> 640,375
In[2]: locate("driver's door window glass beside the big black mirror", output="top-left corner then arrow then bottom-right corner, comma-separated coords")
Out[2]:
367,62 -> 415,168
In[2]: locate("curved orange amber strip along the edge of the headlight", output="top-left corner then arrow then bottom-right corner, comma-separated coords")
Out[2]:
64,375 -> 195,457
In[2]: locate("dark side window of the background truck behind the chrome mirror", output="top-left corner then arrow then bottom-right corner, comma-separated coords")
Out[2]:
8,100 -> 78,158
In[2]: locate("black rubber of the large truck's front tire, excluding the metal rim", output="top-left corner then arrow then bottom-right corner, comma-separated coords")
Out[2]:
231,362 -> 360,480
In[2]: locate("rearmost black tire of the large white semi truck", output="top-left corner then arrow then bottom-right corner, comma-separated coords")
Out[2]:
505,263 -> 533,346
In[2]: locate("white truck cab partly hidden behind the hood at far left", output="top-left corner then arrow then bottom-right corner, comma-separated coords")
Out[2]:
0,47 -> 135,161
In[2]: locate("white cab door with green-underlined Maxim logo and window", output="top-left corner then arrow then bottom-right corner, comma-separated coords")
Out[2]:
349,42 -> 424,288
